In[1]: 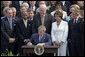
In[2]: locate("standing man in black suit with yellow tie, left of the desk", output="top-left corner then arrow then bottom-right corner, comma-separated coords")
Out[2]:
15,12 -> 31,55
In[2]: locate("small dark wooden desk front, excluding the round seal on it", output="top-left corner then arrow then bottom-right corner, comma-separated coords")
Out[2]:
22,46 -> 58,56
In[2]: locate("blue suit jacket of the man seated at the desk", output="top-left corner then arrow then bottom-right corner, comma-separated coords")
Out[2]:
31,33 -> 52,45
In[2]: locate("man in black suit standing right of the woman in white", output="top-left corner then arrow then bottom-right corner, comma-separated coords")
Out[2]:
68,10 -> 81,56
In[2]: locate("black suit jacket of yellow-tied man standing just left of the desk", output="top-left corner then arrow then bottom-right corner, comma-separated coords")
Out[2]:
15,19 -> 31,41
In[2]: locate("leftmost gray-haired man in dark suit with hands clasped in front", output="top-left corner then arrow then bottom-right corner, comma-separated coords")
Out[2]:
1,8 -> 16,54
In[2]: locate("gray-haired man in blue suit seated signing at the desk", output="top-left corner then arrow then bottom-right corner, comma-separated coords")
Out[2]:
27,25 -> 52,46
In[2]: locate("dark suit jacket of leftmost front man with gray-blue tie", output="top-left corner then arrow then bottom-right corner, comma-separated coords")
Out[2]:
1,17 -> 16,40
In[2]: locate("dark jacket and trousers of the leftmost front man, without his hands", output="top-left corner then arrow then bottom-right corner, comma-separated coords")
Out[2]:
1,17 -> 16,54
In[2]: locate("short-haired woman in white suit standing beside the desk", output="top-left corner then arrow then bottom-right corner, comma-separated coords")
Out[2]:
51,11 -> 68,56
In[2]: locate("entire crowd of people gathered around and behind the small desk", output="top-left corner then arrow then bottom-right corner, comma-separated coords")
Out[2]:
1,1 -> 84,56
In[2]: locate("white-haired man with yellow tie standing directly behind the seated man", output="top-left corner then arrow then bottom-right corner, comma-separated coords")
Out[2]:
32,5 -> 54,34
